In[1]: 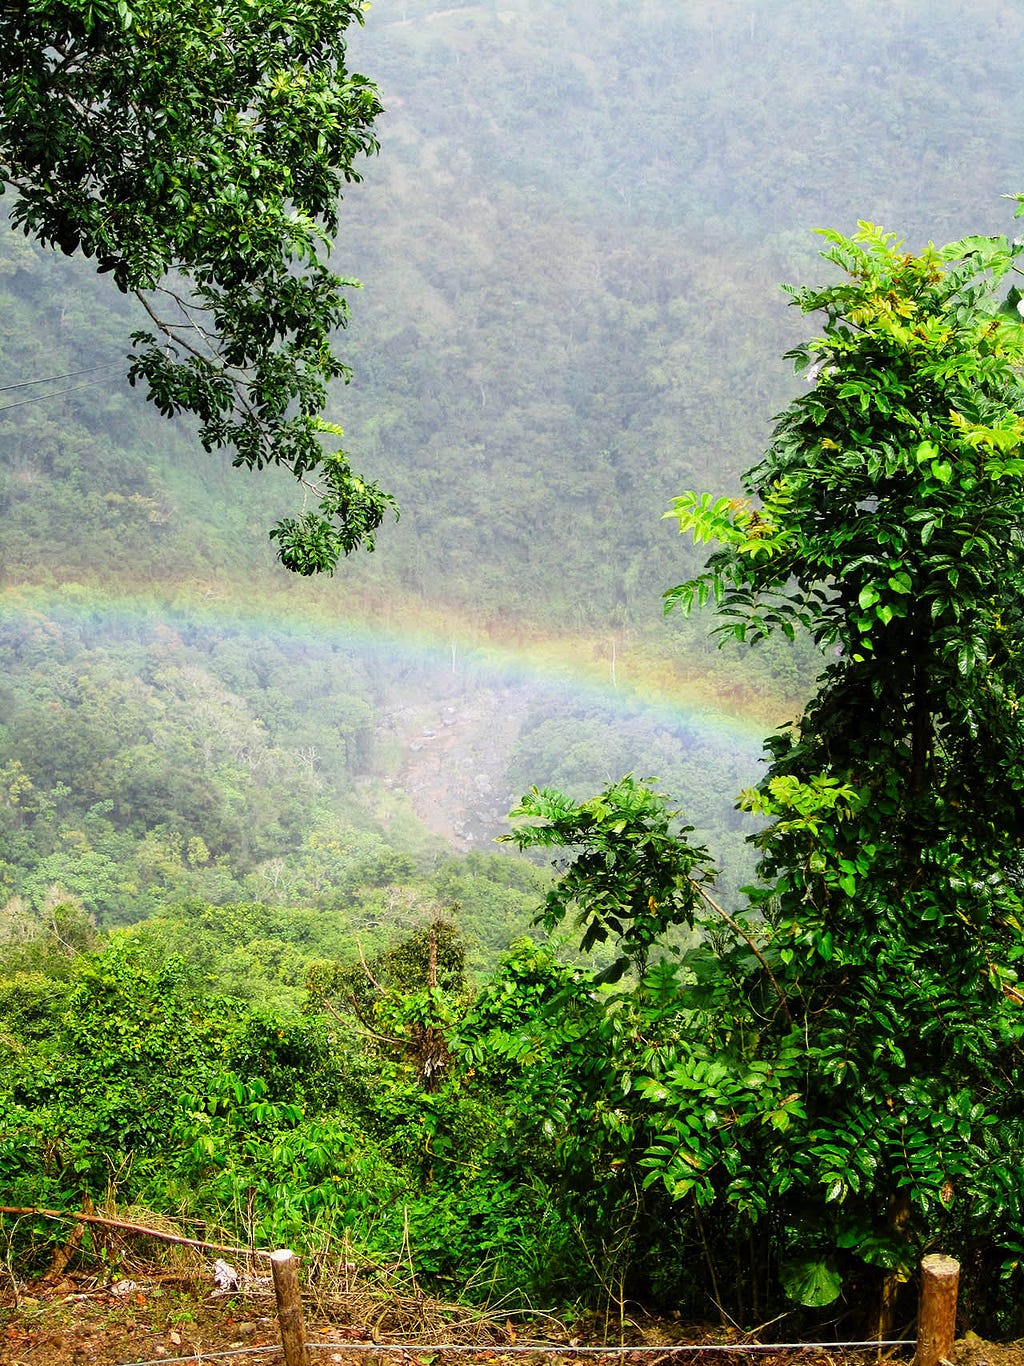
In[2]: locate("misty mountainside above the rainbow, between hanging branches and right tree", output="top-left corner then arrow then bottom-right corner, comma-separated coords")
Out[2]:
339,0 -> 1024,623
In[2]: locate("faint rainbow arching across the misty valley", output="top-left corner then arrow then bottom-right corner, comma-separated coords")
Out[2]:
0,581 -> 796,762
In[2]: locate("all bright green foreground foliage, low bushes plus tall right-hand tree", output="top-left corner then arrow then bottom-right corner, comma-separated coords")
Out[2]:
10,225 -> 1024,1335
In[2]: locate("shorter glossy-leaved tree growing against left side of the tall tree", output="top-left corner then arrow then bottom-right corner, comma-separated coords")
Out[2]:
505,777 -> 801,1313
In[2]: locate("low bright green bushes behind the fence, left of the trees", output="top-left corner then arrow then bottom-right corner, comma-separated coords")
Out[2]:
0,906 -> 622,1298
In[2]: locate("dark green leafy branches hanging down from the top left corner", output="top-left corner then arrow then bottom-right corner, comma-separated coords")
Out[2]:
0,0 -> 393,574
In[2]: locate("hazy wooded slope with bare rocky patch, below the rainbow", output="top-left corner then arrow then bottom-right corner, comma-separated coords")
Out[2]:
0,590 -> 752,939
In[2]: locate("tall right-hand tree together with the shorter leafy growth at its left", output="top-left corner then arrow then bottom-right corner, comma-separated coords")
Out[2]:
517,224 -> 1024,1330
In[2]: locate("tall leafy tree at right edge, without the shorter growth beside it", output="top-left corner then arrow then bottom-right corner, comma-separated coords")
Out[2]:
669,224 -> 1024,1322
